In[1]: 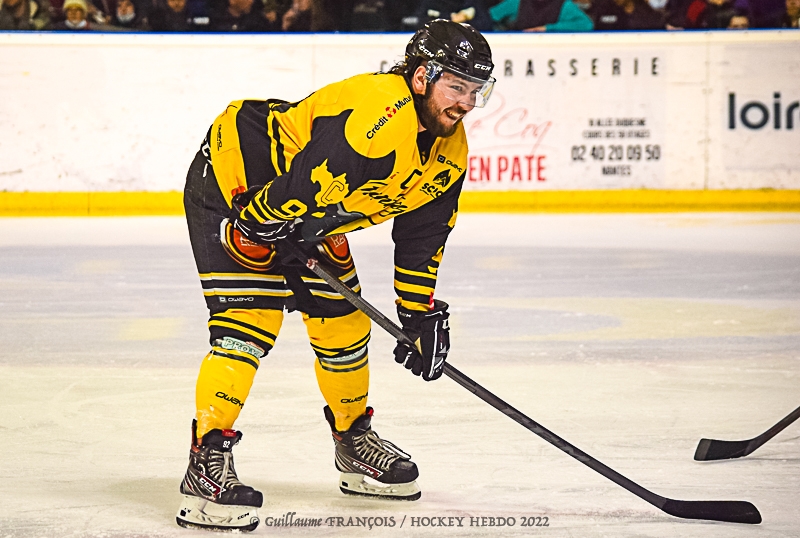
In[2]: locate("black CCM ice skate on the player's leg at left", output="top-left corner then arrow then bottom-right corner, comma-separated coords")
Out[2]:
175,421 -> 263,532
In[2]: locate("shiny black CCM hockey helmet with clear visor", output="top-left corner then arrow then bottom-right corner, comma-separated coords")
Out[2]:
405,19 -> 495,107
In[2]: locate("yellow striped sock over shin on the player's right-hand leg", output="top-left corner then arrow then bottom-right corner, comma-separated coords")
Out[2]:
303,311 -> 370,431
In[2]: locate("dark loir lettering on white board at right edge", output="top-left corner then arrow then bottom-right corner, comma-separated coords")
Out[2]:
728,92 -> 800,131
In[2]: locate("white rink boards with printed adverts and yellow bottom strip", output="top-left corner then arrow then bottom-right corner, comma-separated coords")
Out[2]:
0,31 -> 800,210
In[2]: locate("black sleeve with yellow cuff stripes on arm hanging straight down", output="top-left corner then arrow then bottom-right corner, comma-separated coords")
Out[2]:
392,170 -> 464,310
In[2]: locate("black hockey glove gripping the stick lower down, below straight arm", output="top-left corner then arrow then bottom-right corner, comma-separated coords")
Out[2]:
394,300 -> 450,381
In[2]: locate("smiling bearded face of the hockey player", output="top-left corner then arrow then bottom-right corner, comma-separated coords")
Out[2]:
419,73 -> 481,138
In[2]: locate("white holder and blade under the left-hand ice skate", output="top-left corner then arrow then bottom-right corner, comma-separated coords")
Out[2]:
175,495 -> 259,532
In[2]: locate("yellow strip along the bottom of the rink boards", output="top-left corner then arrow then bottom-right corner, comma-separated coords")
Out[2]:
0,189 -> 800,217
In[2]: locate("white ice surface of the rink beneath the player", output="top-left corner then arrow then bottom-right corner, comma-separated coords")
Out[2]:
0,213 -> 800,538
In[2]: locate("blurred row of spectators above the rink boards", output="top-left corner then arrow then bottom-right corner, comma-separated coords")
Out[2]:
0,0 -> 800,32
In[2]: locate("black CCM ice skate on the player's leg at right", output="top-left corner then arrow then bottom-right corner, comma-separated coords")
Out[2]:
325,406 -> 422,501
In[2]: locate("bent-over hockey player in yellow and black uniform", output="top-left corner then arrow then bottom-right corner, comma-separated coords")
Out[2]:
177,20 -> 494,531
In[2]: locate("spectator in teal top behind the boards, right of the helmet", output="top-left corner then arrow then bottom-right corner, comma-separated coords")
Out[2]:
489,0 -> 594,32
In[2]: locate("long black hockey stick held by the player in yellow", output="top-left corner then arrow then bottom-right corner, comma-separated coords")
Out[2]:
278,245 -> 761,524
